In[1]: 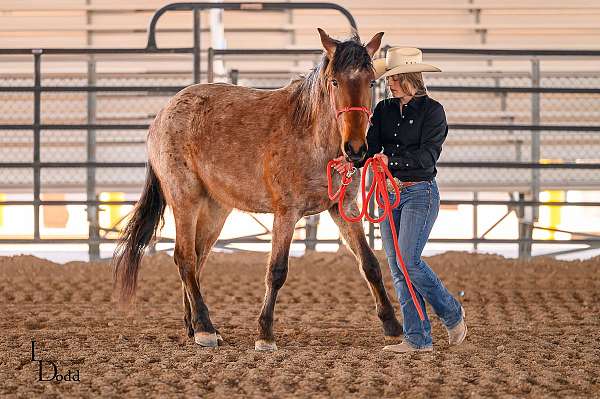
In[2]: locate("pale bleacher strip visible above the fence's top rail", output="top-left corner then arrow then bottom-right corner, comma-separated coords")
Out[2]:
0,0 -> 600,48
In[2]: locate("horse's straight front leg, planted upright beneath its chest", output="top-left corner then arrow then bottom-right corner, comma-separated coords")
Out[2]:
254,211 -> 301,351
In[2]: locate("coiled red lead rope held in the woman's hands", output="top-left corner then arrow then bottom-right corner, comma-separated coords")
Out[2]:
327,158 -> 425,321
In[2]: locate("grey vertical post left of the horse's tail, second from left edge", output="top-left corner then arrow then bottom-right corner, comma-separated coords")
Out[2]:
86,55 -> 99,261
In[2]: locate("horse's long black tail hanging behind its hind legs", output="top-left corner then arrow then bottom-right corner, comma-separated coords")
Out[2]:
112,164 -> 166,304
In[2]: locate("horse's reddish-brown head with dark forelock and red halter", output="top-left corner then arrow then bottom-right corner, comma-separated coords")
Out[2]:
318,28 -> 383,162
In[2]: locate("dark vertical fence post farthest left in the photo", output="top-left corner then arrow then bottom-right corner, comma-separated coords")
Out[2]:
33,49 -> 42,240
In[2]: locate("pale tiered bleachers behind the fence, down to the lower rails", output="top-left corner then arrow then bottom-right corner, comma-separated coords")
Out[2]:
0,0 -> 600,192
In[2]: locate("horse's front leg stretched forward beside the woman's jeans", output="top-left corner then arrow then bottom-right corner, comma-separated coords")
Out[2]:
329,201 -> 402,337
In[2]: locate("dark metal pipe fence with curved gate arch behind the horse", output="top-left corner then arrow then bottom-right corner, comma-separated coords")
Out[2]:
0,3 -> 600,259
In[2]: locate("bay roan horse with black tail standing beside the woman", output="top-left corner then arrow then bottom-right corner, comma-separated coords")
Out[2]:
113,29 -> 402,350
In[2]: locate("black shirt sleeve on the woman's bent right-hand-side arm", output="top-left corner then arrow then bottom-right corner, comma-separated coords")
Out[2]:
390,103 -> 448,169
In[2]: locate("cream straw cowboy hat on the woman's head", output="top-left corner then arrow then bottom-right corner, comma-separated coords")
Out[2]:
373,47 -> 442,79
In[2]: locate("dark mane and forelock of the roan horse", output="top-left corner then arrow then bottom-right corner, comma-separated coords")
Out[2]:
291,33 -> 373,126
